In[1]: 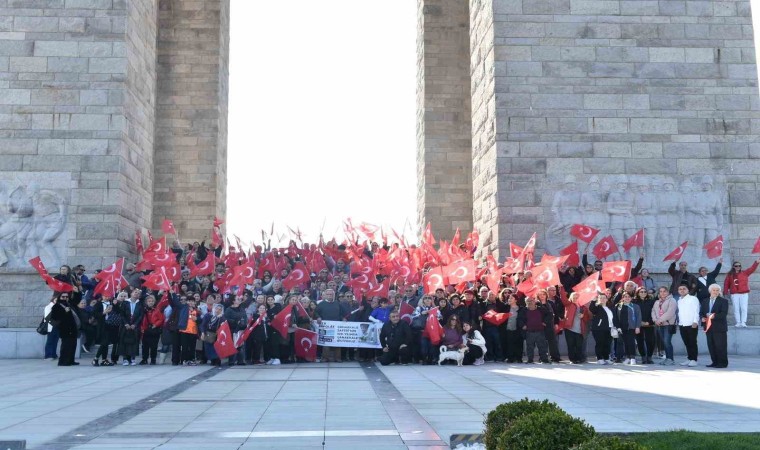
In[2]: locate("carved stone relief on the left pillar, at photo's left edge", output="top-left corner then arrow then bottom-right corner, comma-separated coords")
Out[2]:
0,182 -> 67,268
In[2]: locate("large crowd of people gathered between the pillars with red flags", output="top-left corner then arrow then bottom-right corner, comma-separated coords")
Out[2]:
41,237 -> 760,368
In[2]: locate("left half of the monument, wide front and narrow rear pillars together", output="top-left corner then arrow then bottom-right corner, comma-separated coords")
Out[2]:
0,0 -> 230,342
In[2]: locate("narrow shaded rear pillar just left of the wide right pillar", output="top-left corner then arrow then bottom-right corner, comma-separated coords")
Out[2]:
417,0 -> 472,239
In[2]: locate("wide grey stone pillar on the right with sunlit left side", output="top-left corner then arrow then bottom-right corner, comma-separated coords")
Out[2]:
470,0 -> 760,323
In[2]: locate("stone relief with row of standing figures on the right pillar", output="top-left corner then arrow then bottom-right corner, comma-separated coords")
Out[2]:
546,175 -> 730,271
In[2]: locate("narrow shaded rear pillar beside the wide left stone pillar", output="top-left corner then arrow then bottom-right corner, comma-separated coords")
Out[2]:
153,0 -> 230,241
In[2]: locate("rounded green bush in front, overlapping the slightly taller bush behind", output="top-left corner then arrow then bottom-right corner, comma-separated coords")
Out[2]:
496,410 -> 596,450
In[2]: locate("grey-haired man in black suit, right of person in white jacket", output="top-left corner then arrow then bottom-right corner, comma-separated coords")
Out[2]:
699,283 -> 728,369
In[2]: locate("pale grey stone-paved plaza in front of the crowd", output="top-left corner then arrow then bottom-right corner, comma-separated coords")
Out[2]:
0,357 -> 760,450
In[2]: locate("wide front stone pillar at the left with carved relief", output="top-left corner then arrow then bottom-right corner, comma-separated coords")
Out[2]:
0,0 -> 157,326
